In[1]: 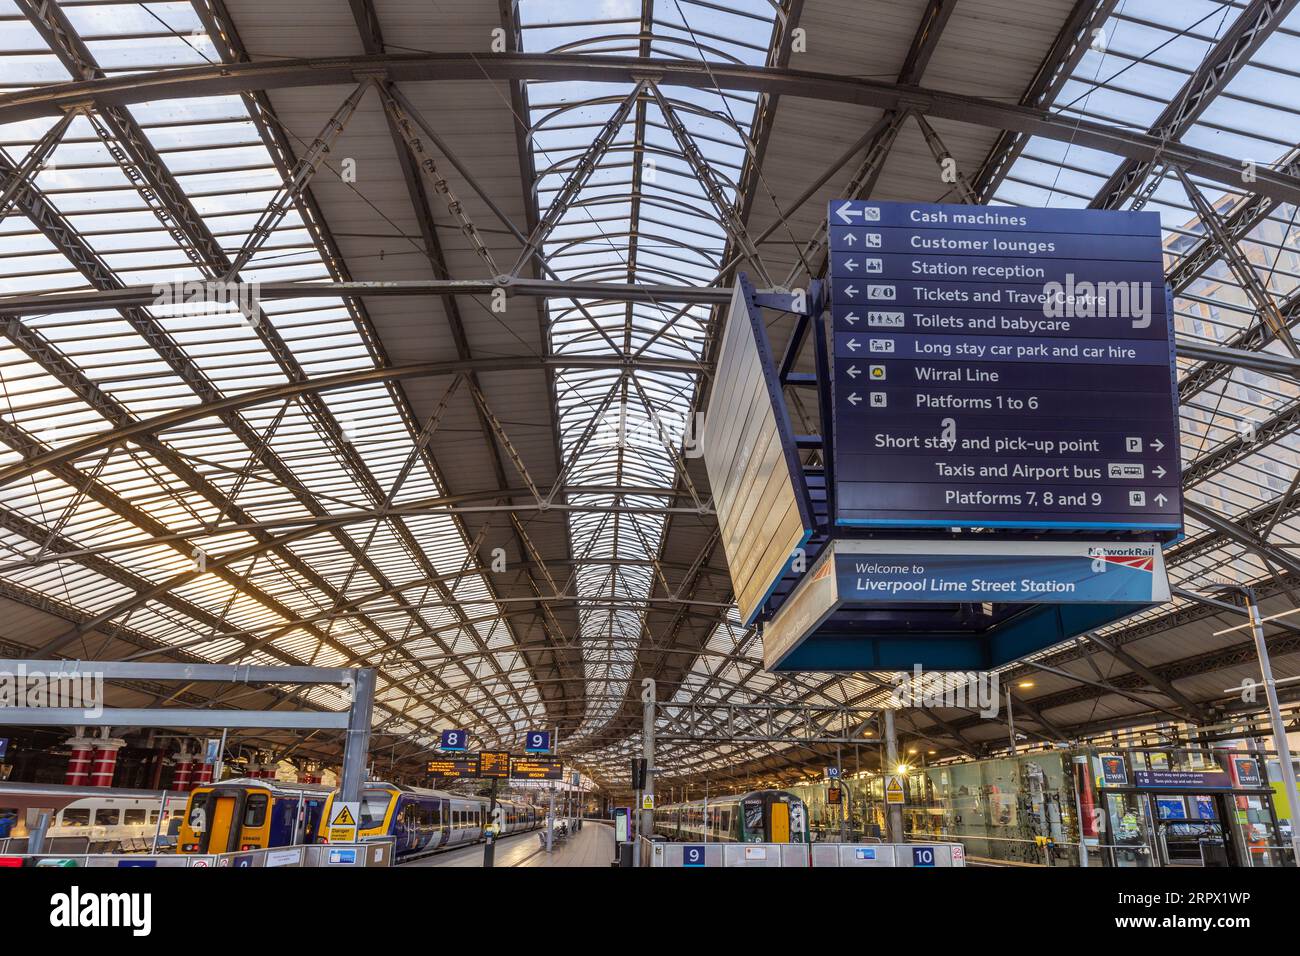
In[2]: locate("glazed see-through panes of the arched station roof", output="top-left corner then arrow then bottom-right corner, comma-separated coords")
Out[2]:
0,0 -> 1300,779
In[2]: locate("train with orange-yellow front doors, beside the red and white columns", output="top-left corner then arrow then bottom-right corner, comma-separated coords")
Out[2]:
176,778 -> 330,853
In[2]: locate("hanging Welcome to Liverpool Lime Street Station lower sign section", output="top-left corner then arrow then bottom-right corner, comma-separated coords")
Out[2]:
763,538 -> 1170,671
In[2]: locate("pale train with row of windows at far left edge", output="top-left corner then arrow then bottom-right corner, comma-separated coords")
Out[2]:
0,783 -> 189,852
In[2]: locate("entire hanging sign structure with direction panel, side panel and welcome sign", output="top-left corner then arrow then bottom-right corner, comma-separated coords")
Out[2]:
705,200 -> 1182,671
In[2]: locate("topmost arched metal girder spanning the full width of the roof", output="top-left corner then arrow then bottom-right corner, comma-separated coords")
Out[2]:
0,54 -> 1300,203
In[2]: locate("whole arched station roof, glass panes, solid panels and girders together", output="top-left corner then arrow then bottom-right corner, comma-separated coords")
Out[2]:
0,0 -> 1300,786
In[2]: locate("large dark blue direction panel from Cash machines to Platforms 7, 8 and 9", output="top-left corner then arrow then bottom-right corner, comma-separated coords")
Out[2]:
828,200 -> 1182,531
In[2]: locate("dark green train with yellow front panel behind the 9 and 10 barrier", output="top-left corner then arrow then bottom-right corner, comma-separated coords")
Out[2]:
654,790 -> 811,843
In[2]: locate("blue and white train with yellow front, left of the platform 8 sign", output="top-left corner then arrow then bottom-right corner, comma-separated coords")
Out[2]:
320,780 -> 546,862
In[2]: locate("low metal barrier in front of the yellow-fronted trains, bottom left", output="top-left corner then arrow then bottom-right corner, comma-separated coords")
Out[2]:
3,840 -> 393,869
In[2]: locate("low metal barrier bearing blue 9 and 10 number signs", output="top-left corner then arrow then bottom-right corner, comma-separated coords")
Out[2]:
642,840 -> 966,869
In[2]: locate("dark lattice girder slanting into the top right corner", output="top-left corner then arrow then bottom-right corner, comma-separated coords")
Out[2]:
1089,0 -> 1297,209
